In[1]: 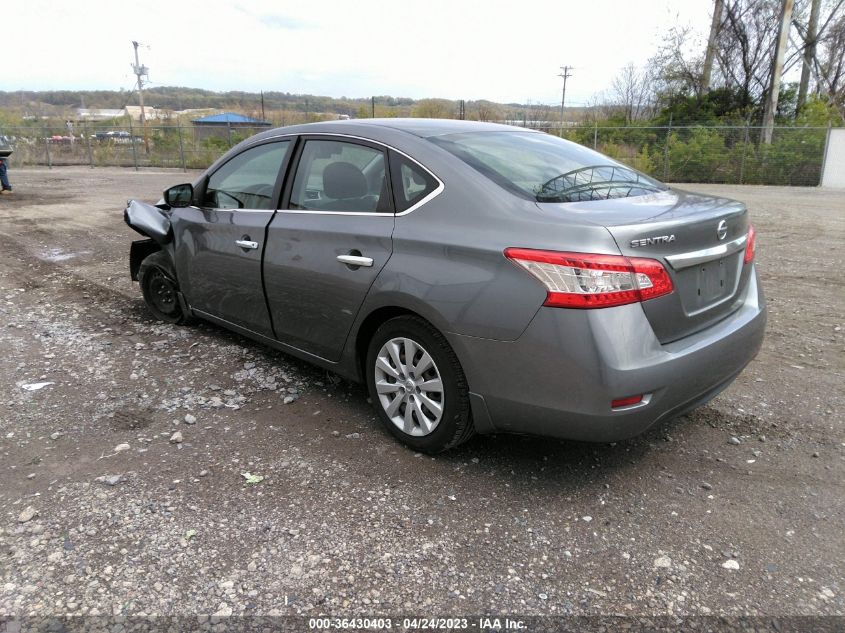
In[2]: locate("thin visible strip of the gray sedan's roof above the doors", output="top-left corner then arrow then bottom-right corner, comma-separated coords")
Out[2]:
251,118 -> 533,138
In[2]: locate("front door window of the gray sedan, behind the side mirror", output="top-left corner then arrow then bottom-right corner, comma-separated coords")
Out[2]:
202,141 -> 291,209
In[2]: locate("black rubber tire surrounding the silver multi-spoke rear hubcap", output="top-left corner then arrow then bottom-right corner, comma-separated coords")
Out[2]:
366,315 -> 475,454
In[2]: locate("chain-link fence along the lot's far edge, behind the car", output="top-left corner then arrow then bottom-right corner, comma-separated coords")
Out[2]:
0,124 -> 829,186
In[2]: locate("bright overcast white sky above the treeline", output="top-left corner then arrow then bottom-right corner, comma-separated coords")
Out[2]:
9,0 -> 713,105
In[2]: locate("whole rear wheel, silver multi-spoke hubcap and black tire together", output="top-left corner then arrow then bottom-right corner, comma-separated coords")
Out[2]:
366,316 -> 475,453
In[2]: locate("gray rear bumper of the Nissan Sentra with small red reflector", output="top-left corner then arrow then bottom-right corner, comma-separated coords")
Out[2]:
449,271 -> 766,442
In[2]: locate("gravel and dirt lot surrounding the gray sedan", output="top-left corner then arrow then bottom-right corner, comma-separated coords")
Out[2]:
0,168 -> 845,628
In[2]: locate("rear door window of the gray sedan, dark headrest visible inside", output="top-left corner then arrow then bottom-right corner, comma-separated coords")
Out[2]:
290,139 -> 393,213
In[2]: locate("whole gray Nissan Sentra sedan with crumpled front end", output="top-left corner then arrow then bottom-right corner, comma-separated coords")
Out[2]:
125,119 -> 766,452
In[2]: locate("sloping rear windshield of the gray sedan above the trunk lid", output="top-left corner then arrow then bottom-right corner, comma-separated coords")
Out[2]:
428,131 -> 666,202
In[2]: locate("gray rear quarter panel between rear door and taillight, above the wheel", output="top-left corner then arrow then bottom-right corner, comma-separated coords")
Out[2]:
354,141 -> 619,341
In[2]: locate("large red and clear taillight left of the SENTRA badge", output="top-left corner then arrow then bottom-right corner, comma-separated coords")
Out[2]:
505,248 -> 673,308
